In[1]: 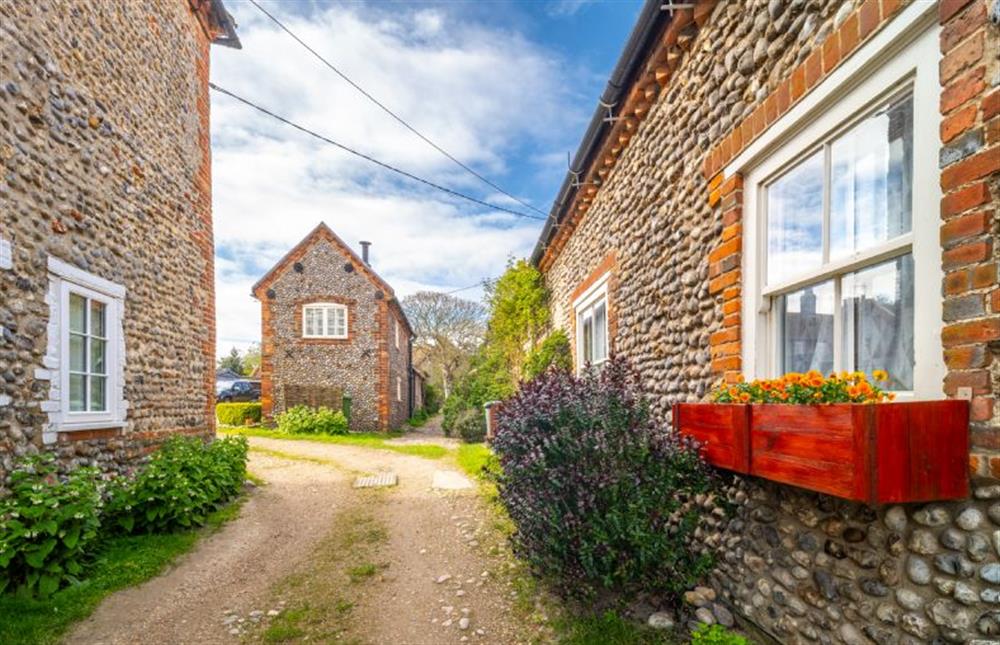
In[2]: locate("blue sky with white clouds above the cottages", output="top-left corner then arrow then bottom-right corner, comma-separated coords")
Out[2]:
212,0 -> 642,354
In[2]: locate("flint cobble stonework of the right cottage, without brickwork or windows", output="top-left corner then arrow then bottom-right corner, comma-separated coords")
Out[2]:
543,0 -> 1000,644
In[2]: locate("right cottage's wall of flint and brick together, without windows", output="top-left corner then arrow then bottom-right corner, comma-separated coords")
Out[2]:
540,0 -> 1000,644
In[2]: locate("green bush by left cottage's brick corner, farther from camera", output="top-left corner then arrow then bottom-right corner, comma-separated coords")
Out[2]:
108,436 -> 248,533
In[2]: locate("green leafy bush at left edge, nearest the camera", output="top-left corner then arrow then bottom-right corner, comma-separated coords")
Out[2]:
0,455 -> 101,596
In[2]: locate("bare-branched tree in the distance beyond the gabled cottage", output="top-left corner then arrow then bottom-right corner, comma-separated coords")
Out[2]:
402,291 -> 486,398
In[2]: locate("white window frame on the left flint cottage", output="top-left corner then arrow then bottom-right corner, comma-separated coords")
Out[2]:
48,257 -> 127,432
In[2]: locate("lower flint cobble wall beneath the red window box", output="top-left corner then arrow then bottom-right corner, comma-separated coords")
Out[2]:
708,477 -> 1000,644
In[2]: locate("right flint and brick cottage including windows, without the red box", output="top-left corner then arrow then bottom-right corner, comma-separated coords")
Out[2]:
533,0 -> 1000,643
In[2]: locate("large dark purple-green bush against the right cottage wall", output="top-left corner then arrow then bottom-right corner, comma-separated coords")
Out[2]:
493,359 -> 711,595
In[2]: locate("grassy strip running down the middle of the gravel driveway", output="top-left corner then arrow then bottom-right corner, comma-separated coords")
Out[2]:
248,504 -> 389,643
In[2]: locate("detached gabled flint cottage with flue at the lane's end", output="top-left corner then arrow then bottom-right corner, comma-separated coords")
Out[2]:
253,224 -> 421,430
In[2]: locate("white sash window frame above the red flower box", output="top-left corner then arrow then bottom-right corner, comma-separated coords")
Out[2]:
724,3 -> 945,399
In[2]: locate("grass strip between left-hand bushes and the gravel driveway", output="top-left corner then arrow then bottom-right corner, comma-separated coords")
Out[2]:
0,496 -> 246,645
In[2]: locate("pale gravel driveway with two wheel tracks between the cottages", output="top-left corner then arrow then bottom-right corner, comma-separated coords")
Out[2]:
67,438 -> 522,645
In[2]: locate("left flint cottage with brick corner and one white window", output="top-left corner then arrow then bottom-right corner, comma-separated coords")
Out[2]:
0,0 -> 239,485
